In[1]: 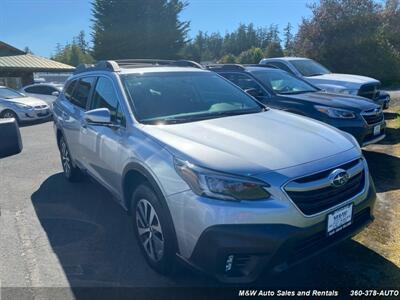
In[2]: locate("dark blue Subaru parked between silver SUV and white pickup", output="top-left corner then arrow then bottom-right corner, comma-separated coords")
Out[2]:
208,64 -> 385,146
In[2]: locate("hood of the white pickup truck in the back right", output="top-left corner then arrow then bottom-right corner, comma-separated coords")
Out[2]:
305,73 -> 379,89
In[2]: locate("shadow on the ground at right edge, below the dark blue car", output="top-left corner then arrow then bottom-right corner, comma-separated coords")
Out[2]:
363,150 -> 400,193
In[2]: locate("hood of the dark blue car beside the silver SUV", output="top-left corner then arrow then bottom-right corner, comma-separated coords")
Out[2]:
283,92 -> 380,112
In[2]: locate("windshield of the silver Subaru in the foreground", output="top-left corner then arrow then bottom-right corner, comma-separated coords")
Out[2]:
121,72 -> 264,124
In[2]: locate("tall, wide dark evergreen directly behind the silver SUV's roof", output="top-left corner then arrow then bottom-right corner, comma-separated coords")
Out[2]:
92,0 -> 189,59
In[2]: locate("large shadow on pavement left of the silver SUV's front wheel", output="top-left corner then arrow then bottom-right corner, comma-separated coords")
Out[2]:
31,173 -> 209,287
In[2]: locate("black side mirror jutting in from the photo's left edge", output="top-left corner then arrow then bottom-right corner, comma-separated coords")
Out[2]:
0,119 -> 22,158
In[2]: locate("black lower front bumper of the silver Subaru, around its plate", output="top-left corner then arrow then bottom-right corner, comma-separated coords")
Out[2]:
186,180 -> 376,283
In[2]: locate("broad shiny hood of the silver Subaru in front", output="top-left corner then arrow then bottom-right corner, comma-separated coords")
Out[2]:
142,109 -> 355,175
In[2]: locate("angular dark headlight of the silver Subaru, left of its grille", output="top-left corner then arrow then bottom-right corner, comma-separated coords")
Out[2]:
174,158 -> 271,201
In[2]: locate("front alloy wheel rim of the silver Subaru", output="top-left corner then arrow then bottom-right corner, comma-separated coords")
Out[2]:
136,199 -> 164,262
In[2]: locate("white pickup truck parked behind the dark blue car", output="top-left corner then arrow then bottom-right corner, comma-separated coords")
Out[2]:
260,57 -> 390,109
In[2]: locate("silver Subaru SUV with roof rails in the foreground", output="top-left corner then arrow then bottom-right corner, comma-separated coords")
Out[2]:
54,60 -> 376,282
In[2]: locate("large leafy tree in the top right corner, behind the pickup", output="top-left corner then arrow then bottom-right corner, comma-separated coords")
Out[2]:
295,0 -> 400,83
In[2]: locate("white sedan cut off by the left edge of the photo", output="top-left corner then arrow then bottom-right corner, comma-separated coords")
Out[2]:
0,86 -> 51,122
